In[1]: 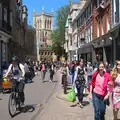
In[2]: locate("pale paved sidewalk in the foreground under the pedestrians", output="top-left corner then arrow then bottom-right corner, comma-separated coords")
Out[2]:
37,71 -> 119,120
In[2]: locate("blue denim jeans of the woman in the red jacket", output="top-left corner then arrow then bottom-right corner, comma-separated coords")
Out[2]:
93,92 -> 106,120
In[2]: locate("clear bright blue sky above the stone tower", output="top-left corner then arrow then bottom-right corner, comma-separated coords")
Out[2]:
23,0 -> 80,24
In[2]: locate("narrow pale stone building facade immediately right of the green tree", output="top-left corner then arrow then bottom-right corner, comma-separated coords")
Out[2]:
64,0 -> 85,61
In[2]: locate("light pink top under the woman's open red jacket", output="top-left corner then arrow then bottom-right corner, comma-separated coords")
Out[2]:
94,74 -> 104,96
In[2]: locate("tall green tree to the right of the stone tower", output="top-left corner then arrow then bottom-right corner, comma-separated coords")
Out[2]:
51,5 -> 69,59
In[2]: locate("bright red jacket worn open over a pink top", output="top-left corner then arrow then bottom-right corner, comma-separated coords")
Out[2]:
91,72 -> 112,95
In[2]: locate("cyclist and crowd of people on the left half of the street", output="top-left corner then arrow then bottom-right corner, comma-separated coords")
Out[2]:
2,56 -> 56,104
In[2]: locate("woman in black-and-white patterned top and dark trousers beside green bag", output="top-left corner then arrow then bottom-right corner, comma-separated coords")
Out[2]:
74,59 -> 86,108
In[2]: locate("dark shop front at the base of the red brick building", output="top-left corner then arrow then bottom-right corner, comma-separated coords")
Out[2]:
93,33 -> 113,64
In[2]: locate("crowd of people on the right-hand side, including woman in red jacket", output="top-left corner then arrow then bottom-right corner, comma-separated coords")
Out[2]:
61,59 -> 120,120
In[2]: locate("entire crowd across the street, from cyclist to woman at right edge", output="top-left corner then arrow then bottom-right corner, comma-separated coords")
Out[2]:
1,56 -> 120,120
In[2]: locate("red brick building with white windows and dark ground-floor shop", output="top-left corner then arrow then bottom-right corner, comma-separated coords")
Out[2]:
92,0 -> 112,63
